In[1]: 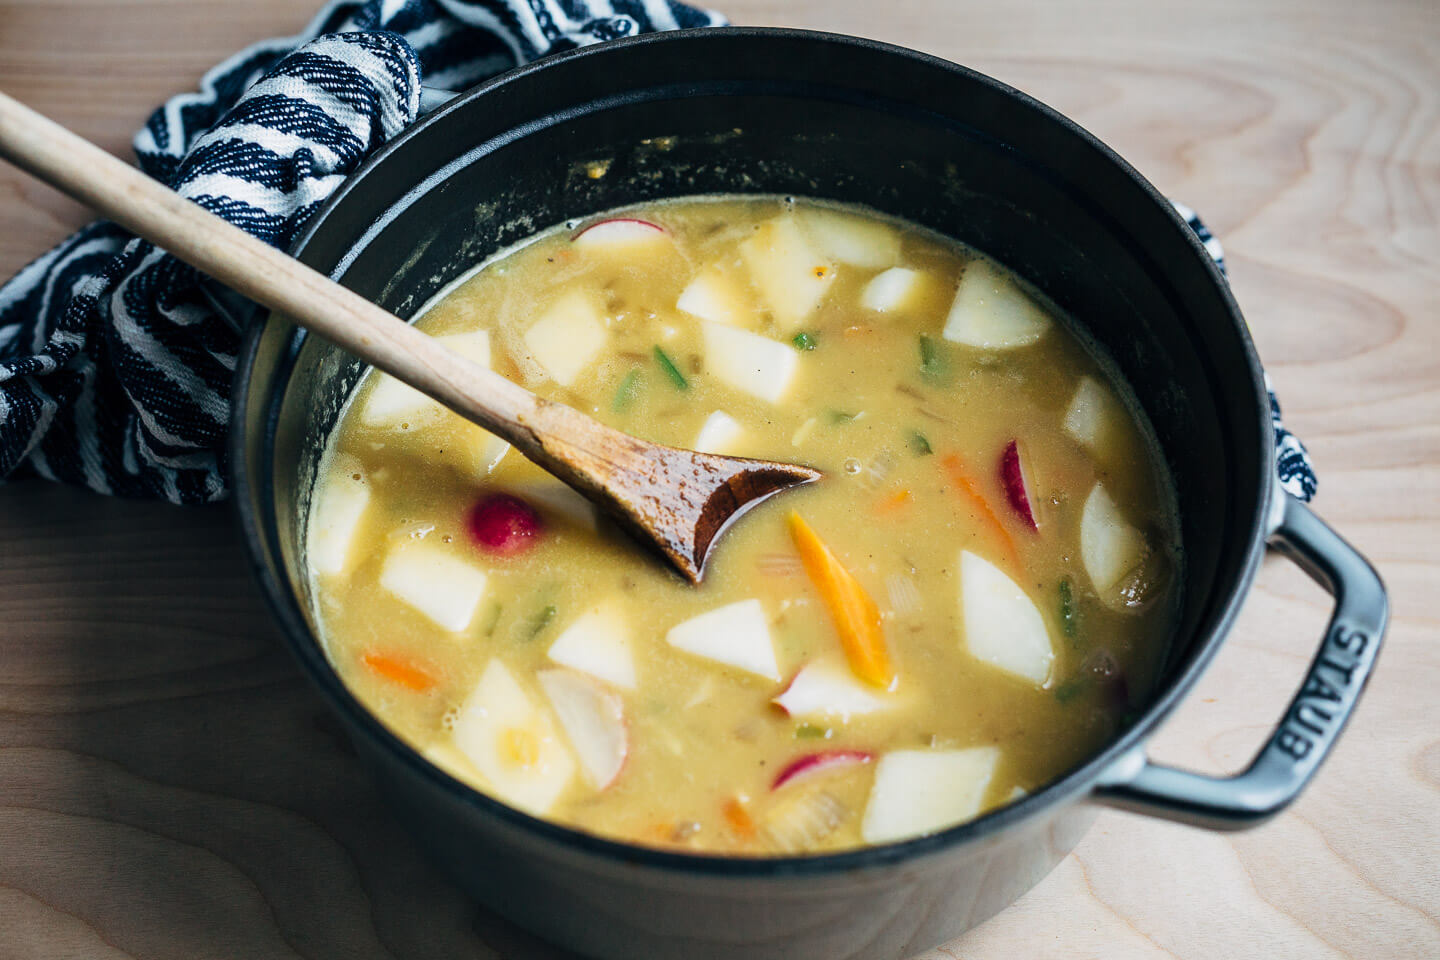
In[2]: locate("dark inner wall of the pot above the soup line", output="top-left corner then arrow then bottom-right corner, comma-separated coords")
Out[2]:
236,30 -> 1270,840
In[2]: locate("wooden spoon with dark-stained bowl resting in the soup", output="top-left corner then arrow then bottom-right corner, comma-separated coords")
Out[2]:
0,94 -> 821,583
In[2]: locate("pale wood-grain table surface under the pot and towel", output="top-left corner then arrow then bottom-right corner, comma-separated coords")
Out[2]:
0,0 -> 1440,960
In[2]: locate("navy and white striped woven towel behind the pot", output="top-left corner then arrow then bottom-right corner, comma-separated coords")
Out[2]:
0,0 -> 1315,504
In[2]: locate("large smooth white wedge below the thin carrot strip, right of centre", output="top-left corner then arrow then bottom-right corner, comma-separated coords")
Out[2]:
959,550 -> 1056,687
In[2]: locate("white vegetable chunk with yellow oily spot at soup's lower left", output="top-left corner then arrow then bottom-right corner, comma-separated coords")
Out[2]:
454,659 -> 575,816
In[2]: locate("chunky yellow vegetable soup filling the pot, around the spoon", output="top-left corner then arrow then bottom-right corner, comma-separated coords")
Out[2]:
305,197 -> 1179,856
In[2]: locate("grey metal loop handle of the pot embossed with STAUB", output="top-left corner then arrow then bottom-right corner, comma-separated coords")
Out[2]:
1093,491 -> 1388,830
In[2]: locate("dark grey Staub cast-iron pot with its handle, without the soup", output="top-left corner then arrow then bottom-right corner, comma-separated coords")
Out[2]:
232,29 -> 1387,960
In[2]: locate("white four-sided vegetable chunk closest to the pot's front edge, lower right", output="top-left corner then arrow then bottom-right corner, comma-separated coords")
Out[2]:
860,747 -> 999,843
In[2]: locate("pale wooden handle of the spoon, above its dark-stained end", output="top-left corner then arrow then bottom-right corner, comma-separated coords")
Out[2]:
0,94 -> 547,453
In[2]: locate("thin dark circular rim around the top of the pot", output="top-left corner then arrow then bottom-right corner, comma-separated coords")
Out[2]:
228,27 -> 1276,878
